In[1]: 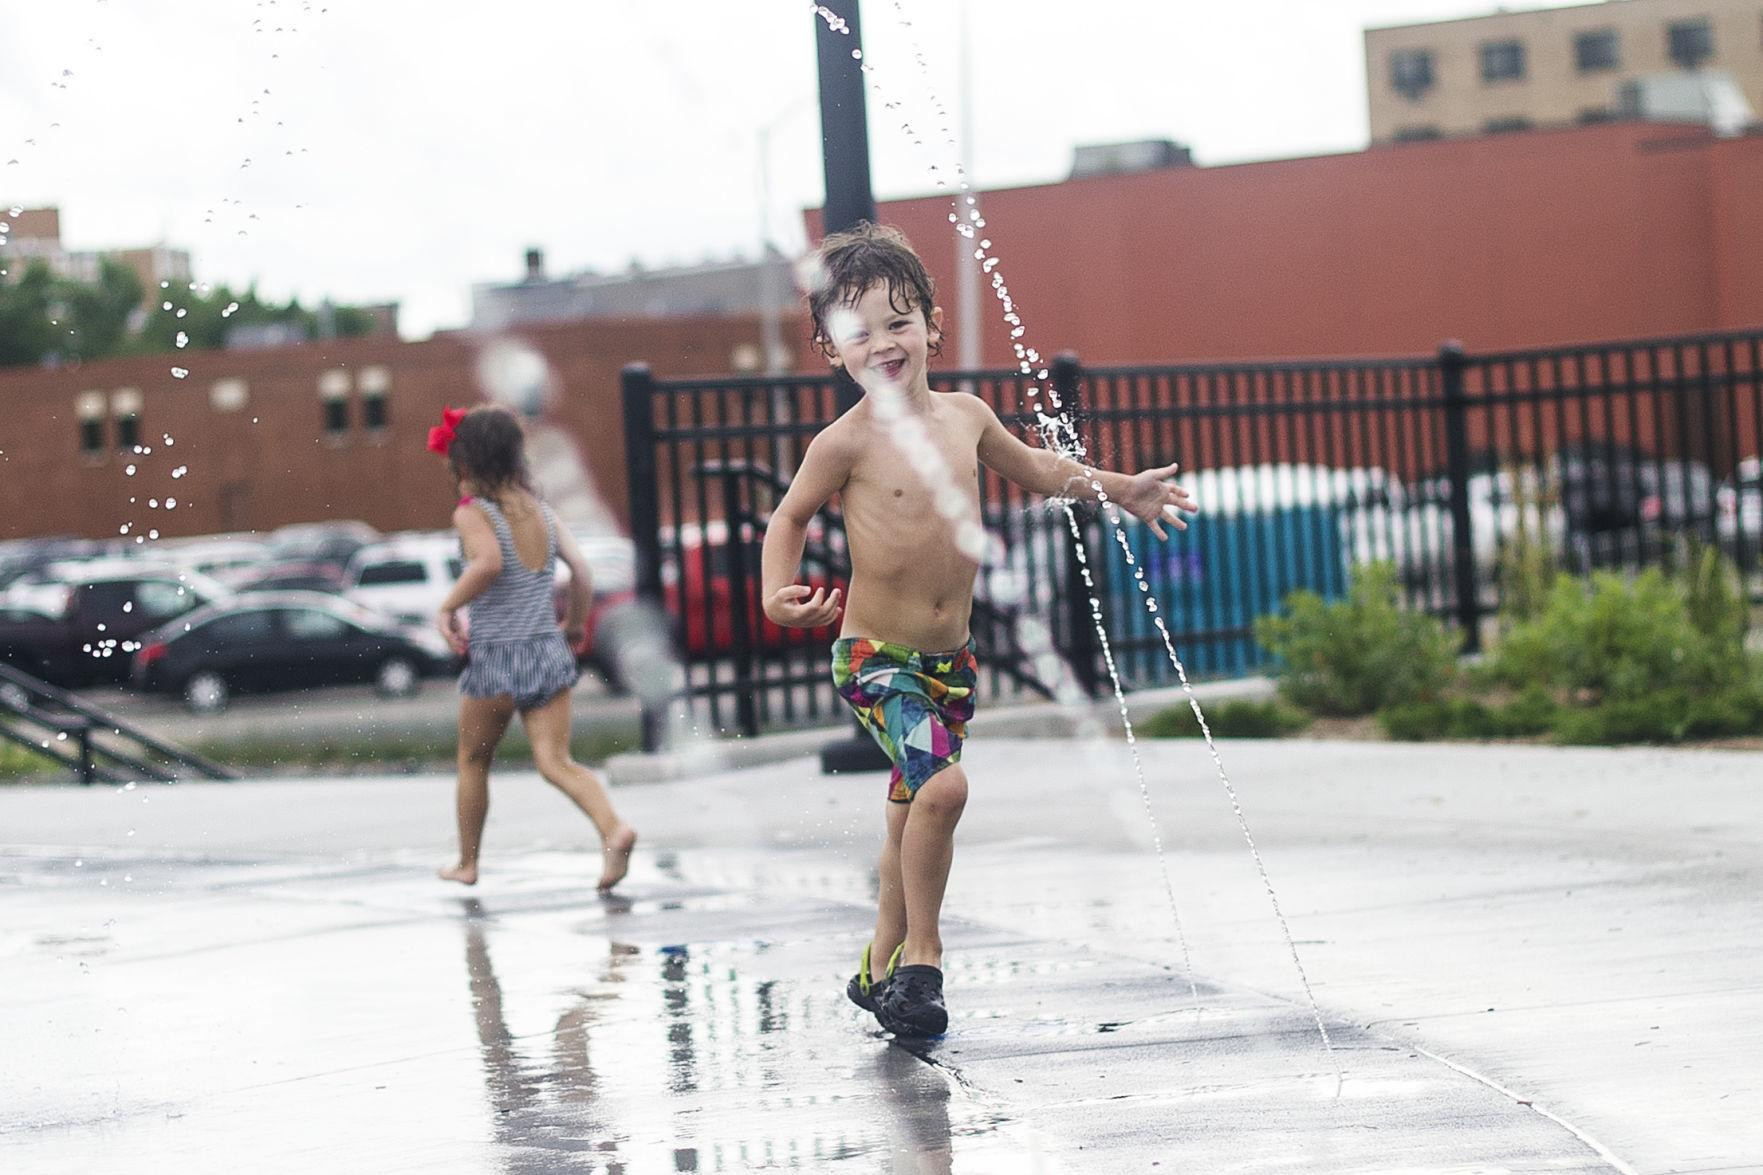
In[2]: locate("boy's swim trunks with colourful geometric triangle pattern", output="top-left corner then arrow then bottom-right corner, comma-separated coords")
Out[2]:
832,637 -> 978,805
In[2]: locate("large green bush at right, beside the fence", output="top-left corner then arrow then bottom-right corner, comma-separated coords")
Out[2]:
1491,568 -> 1749,704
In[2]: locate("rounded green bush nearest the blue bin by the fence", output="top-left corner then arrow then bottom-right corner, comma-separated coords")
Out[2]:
1255,563 -> 1458,715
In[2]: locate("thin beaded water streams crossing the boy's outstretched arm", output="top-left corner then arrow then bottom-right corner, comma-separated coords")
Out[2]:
815,0 -> 1340,1058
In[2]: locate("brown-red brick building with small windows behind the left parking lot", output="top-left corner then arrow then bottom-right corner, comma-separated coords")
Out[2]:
0,310 -> 800,538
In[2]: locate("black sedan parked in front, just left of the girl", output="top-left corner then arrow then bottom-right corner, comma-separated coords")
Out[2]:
132,591 -> 457,713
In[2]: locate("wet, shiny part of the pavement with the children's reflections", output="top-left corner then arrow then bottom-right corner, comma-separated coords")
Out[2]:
0,818 -> 1608,1175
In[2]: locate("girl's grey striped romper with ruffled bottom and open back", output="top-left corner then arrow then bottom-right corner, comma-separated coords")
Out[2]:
458,498 -> 580,711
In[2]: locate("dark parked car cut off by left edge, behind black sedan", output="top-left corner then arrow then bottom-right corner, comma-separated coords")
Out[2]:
0,559 -> 233,686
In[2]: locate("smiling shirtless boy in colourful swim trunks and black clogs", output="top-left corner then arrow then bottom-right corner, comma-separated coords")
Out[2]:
763,224 -> 1195,1036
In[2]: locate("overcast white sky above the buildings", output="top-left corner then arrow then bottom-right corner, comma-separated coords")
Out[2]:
0,0 -> 1593,337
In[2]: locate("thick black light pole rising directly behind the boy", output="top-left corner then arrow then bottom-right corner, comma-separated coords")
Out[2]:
813,0 -> 890,773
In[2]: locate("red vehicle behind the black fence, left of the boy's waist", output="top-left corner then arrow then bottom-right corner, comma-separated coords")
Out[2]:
661,520 -> 844,658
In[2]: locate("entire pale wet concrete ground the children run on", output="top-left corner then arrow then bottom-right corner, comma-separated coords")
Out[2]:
0,730 -> 1763,1175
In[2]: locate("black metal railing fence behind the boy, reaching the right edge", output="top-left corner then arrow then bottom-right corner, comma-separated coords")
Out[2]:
624,332 -> 1763,751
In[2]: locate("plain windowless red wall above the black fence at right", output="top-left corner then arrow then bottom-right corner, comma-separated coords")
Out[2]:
809,123 -> 1763,365
